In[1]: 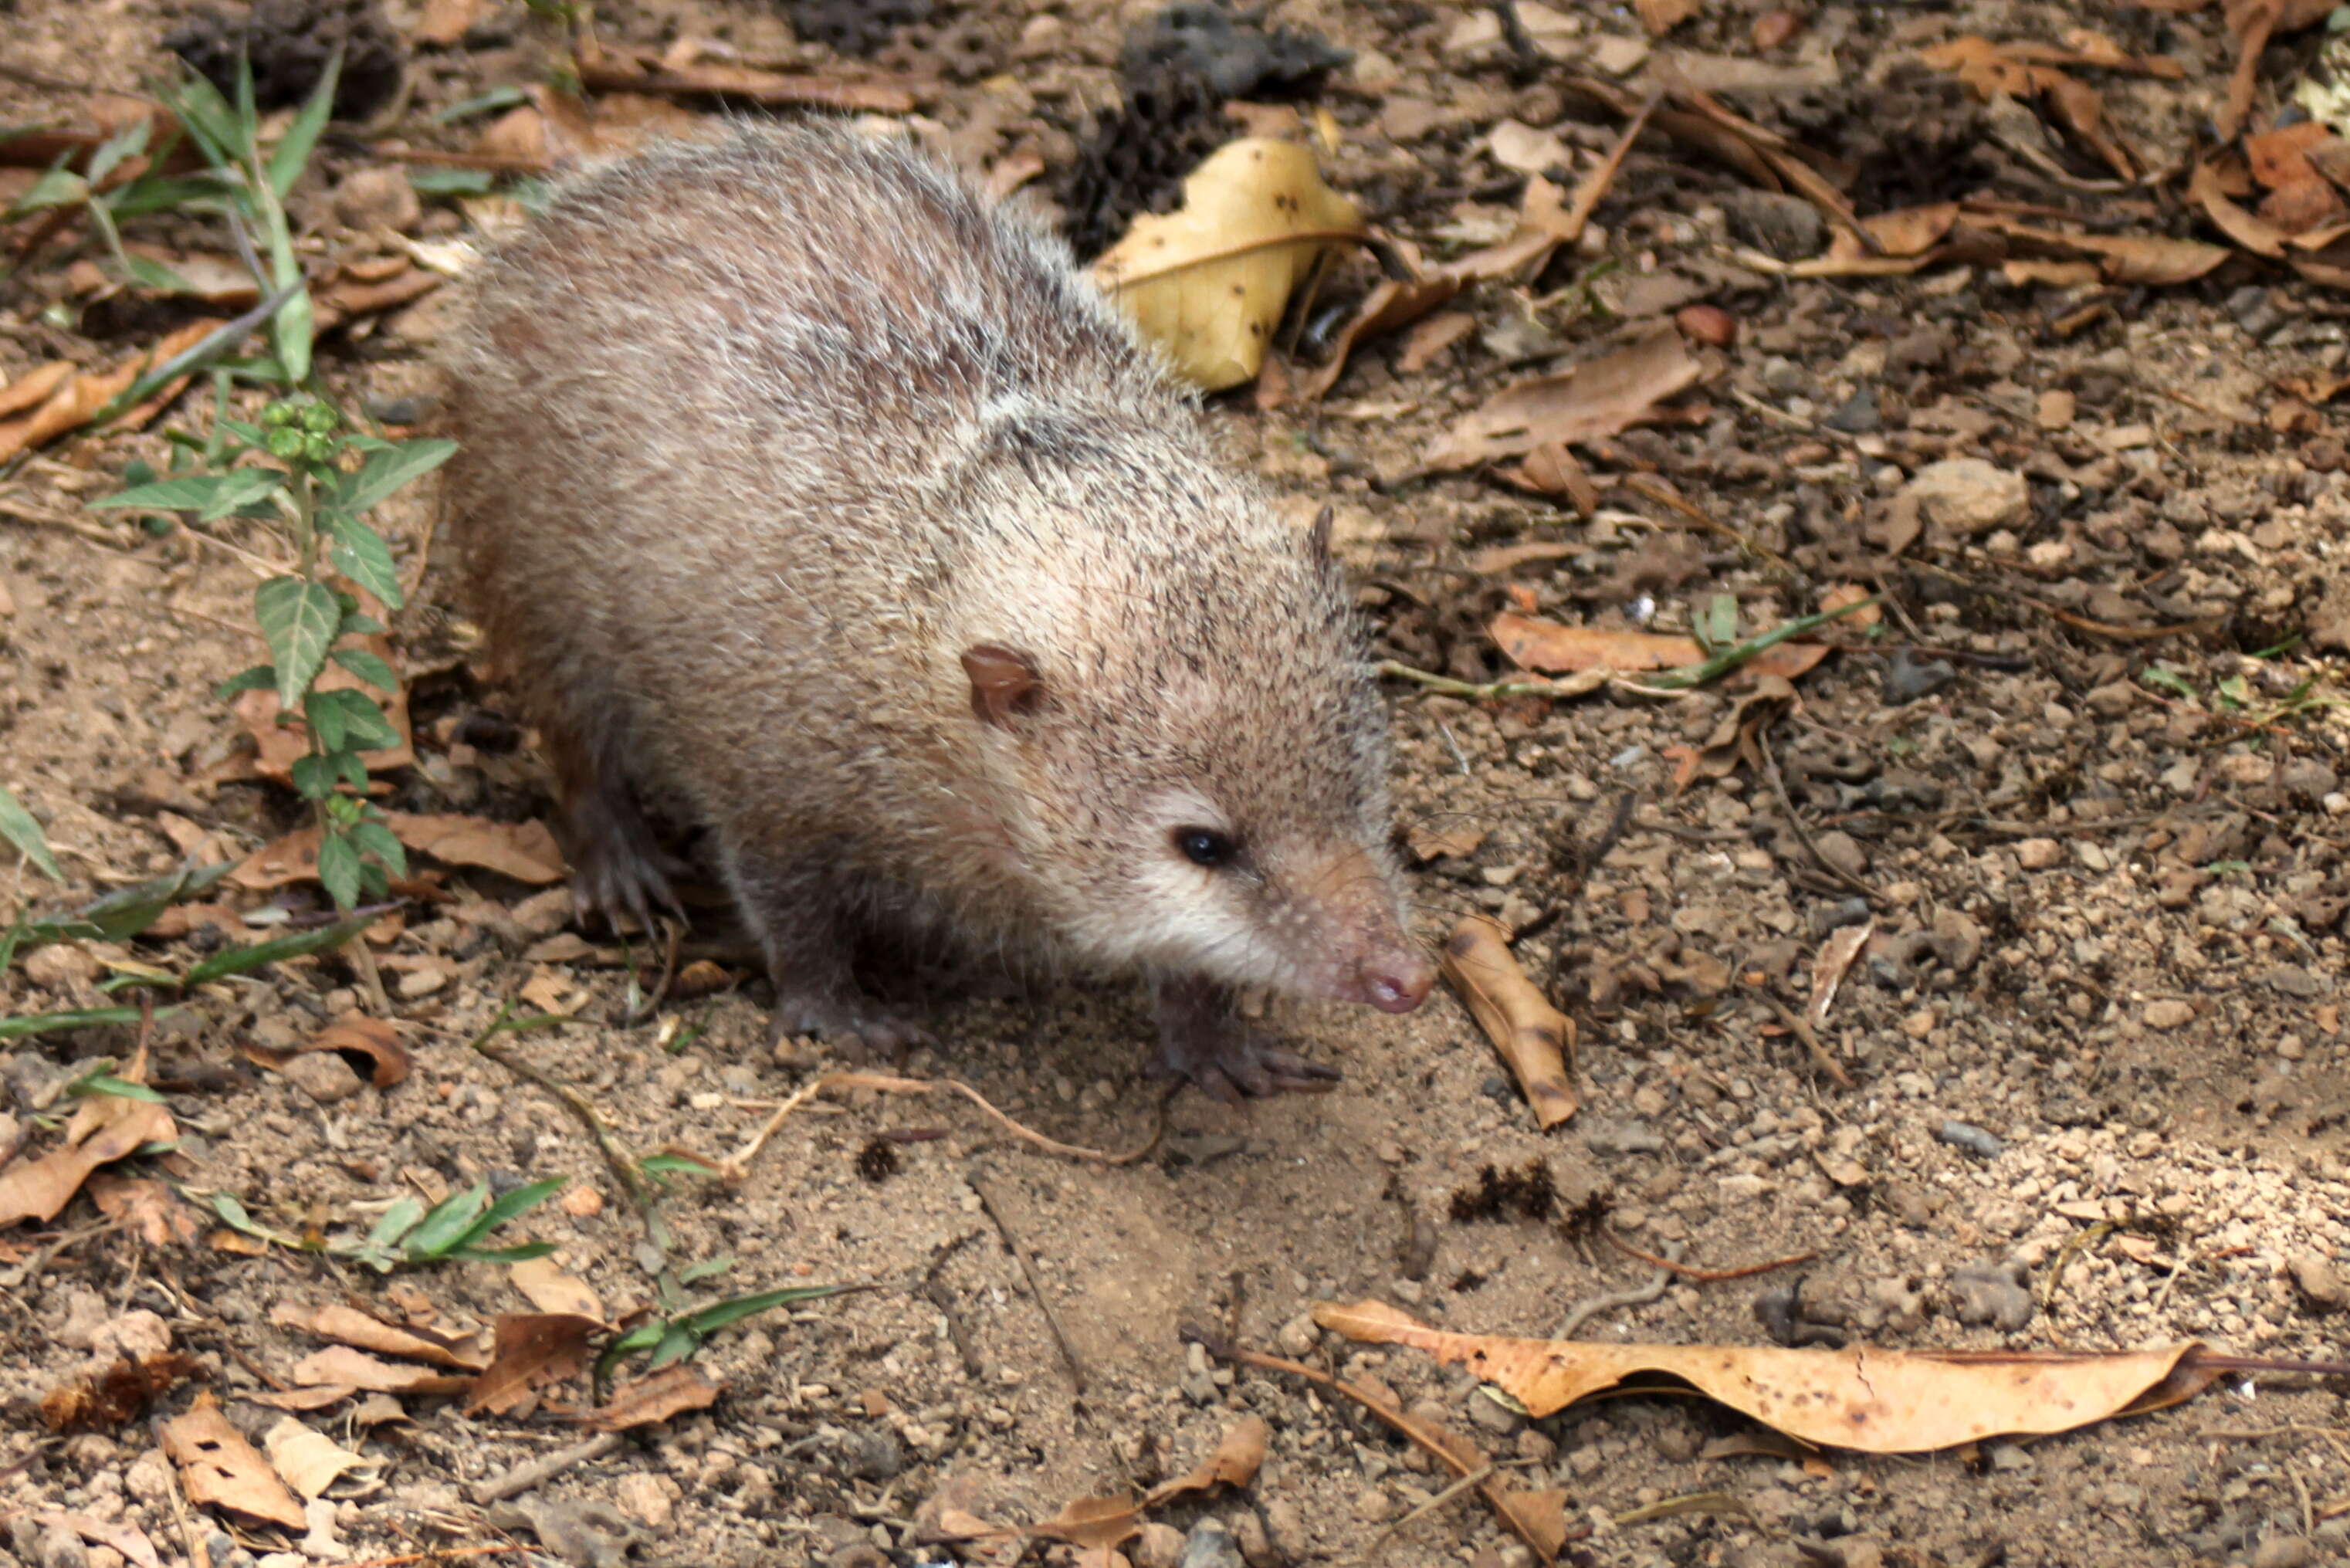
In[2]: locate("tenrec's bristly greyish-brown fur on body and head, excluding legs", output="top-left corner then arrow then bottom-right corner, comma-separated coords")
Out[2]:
446,129 -> 1396,994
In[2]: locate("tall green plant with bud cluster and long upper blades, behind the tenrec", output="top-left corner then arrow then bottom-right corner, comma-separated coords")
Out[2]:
74,55 -> 456,909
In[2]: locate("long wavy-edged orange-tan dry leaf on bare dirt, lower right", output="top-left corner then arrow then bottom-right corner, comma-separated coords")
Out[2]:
1314,1300 -> 2221,1453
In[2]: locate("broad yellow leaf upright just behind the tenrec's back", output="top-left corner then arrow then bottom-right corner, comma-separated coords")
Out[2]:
1092,137 -> 1366,393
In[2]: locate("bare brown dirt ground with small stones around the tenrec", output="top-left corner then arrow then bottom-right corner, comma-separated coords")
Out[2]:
0,0 -> 2350,1568
